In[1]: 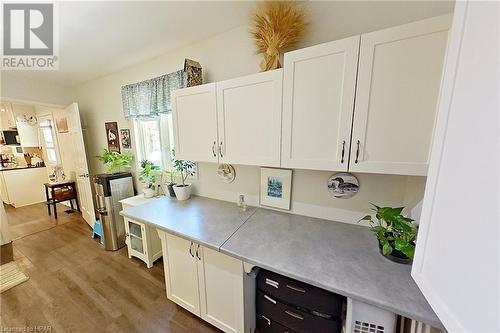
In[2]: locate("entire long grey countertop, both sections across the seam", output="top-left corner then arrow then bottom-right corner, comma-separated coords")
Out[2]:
121,197 -> 443,328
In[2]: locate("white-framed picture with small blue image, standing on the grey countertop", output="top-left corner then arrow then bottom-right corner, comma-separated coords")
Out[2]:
260,168 -> 292,210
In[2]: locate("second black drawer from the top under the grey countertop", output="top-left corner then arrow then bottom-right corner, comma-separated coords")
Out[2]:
257,290 -> 341,333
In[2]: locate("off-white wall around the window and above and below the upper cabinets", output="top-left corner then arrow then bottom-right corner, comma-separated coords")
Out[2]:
76,1 -> 453,222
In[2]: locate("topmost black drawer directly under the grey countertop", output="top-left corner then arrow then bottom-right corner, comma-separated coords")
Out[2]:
257,269 -> 343,317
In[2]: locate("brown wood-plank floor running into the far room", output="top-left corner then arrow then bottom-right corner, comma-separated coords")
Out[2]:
0,205 -> 220,333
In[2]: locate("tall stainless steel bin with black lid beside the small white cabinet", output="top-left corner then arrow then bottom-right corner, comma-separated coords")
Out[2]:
94,172 -> 134,251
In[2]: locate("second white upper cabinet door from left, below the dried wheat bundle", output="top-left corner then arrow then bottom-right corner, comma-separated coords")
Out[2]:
217,69 -> 282,167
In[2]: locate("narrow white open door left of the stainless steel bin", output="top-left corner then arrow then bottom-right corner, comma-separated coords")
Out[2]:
65,103 -> 95,227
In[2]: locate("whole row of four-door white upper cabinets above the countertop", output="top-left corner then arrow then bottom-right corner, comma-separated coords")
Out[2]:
172,15 -> 451,175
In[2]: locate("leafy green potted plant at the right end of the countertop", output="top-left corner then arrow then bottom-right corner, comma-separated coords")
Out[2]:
359,204 -> 417,264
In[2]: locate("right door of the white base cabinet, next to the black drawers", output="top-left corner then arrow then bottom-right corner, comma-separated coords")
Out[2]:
197,246 -> 244,333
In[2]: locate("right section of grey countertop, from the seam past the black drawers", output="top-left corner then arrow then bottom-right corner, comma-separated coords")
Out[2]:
220,209 -> 443,328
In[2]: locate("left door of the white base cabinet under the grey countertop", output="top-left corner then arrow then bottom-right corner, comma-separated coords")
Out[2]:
162,234 -> 200,316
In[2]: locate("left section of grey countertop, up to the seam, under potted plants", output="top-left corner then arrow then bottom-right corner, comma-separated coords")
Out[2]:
120,196 -> 256,250
